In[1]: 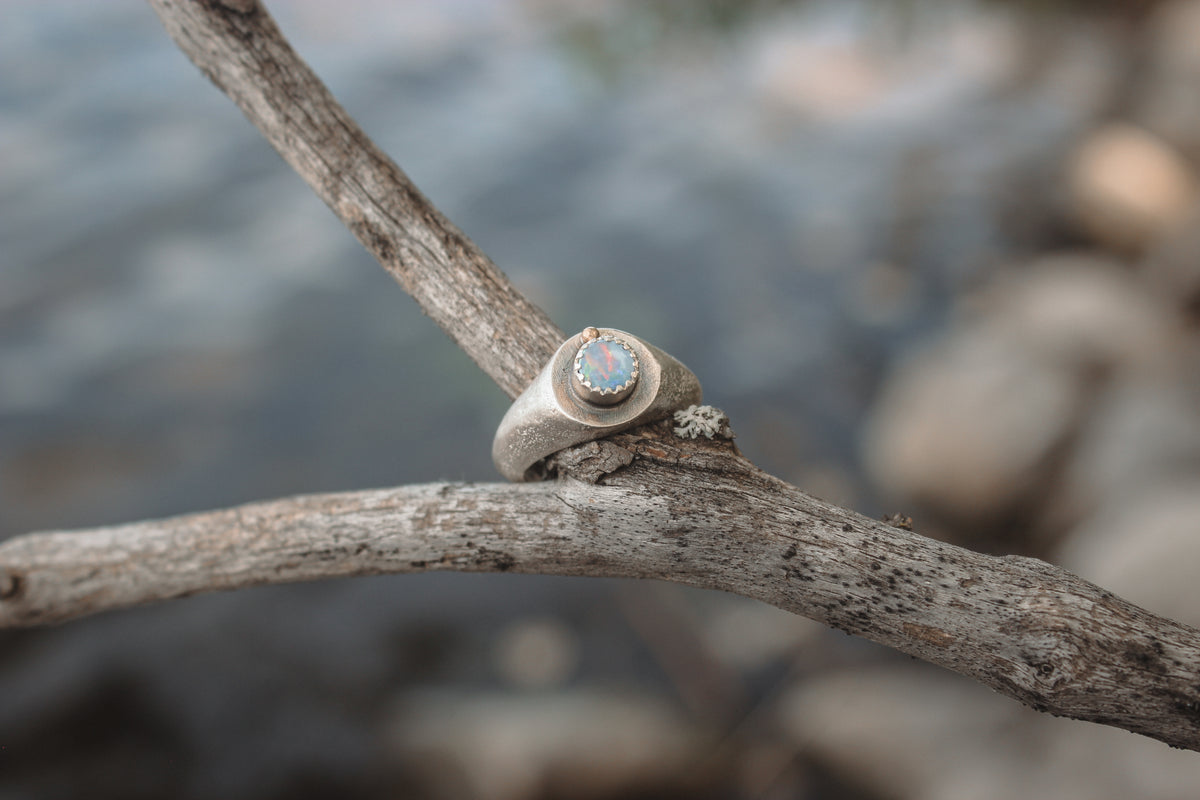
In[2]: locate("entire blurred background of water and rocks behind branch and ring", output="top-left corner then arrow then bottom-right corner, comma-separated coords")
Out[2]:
0,0 -> 1200,800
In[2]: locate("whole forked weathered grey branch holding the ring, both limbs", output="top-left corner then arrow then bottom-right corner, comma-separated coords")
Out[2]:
0,0 -> 1200,750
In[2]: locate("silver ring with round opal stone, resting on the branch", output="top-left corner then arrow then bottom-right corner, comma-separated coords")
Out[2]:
492,327 -> 701,481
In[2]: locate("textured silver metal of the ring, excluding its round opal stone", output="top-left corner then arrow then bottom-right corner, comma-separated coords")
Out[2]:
492,327 -> 702,481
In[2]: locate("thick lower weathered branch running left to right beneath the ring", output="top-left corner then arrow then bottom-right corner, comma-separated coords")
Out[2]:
7,431 -> 1200,750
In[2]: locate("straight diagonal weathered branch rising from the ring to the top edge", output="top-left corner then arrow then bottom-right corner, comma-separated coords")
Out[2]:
149,0 -> 565,397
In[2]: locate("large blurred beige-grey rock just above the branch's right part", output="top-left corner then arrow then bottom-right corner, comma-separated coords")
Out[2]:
866,330 -> 1080,523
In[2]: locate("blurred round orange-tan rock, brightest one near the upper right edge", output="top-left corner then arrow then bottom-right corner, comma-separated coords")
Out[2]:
1068,122 -> 1198,251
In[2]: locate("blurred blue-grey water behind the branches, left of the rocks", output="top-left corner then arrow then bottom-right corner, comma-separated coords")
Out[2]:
0,0 -> 1086,798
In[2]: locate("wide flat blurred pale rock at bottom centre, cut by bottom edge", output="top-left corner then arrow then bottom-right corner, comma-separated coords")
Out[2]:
388,692 -> 712,800
